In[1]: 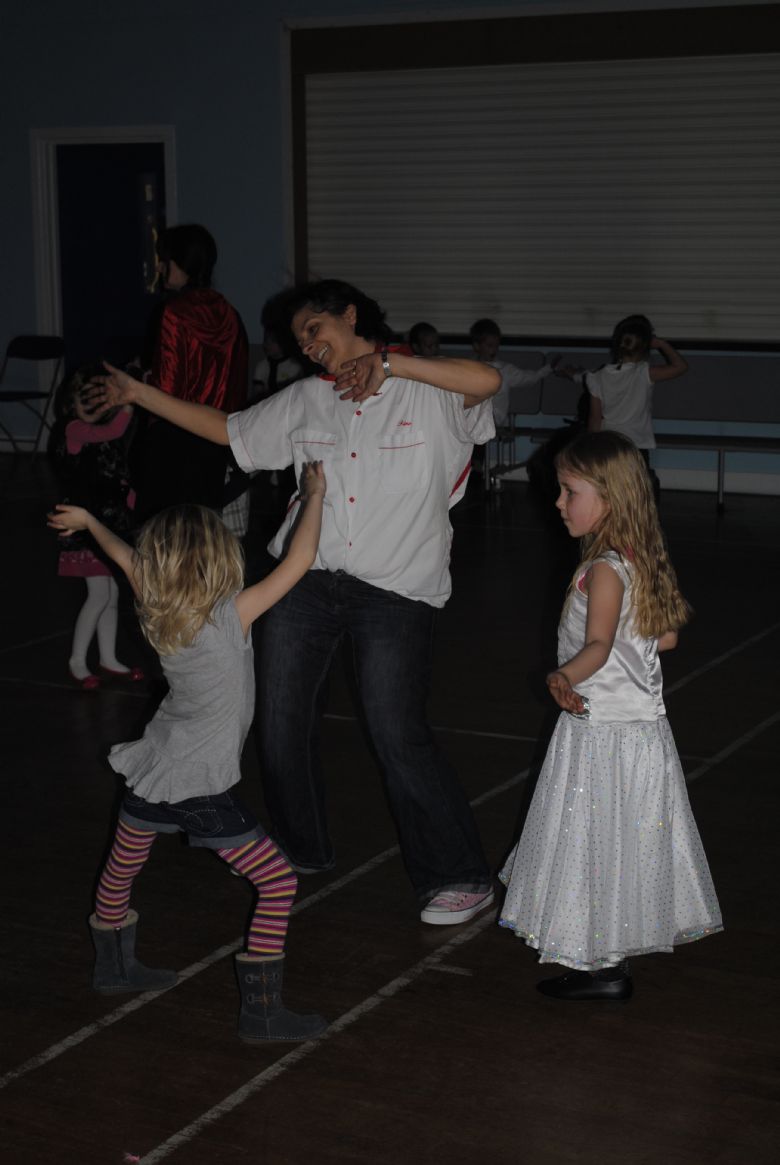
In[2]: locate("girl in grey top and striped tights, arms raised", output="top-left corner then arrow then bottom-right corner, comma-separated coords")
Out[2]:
49,463 -> 326,1042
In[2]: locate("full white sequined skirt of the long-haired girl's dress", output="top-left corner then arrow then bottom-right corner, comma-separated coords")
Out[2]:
499,713 -> 722,969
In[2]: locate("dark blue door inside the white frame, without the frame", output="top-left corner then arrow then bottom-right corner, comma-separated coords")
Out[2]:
57,142 -> 165,370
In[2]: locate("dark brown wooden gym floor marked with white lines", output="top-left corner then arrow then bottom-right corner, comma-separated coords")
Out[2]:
0,458 -> 780,1165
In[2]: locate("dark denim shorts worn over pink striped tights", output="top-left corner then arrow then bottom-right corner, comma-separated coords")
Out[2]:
119,789 -> 265,849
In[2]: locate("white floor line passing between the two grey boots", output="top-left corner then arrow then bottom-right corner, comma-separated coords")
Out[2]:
0,769 -> 527,1089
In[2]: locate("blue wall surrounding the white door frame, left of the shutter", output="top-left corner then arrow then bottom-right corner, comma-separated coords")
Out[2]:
0,0 -> 565,348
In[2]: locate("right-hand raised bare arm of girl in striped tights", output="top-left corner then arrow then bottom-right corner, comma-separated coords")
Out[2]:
235,461 -> 326,635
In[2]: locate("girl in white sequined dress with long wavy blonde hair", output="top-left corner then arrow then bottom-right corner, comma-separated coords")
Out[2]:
501,431 -> 722,1000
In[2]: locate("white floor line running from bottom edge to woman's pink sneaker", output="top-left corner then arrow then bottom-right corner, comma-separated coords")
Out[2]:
134,911 -> 495,1165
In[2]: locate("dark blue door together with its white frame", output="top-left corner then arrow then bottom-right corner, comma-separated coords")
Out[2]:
31,126 -> 176,382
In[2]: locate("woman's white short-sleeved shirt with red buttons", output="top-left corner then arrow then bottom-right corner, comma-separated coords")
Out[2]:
228,376 -> 495,607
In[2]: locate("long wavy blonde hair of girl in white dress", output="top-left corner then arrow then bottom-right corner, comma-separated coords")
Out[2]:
555,430 -> 692,638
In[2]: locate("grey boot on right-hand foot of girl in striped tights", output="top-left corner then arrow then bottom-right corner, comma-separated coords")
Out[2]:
235,954 -> 327,1044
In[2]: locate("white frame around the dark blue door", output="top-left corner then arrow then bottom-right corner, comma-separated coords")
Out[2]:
30,126 -> 178,340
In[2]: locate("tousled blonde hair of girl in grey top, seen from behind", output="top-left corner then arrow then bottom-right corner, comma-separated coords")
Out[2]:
135,504 -> 243,655
